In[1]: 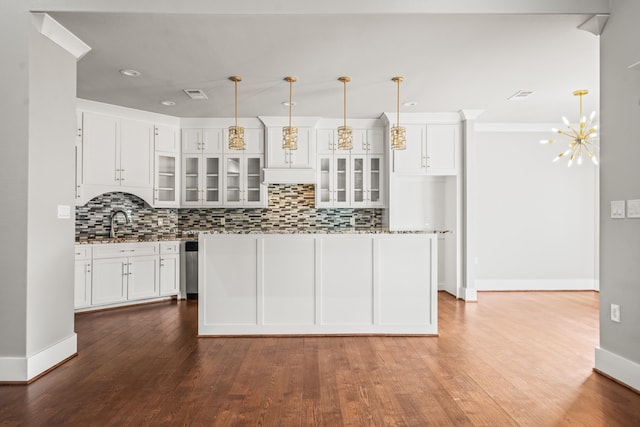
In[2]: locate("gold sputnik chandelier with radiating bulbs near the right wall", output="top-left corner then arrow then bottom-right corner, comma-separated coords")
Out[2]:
540,89 -> 598,167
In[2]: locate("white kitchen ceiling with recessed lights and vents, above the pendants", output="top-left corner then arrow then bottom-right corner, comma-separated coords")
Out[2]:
51,5 -> 599,122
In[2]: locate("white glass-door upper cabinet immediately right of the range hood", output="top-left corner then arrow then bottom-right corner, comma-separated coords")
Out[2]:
316,154 -> 351,208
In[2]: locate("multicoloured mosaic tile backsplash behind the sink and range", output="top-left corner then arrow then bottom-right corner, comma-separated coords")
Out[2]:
76,184 -> 382,241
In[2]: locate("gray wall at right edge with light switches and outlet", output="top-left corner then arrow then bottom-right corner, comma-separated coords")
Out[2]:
600,0 -> 640,364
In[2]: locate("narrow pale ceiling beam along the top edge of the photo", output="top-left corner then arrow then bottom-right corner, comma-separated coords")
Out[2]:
28,0 -> 610,15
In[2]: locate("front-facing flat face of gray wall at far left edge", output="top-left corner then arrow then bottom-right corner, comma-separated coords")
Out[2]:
0,0 -> 31,357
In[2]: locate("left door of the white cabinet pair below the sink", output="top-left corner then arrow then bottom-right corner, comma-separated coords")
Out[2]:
91,258 -> 128,305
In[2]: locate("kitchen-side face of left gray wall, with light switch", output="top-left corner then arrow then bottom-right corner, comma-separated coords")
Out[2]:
27,21 -> 76,356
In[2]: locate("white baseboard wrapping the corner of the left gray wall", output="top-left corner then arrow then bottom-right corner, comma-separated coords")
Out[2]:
0,333 -> 78,382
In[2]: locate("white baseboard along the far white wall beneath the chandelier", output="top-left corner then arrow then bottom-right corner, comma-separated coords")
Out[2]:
474,279 -> 598,291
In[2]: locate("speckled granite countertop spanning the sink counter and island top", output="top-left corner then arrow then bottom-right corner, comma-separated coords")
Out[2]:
76,231 -> 451,245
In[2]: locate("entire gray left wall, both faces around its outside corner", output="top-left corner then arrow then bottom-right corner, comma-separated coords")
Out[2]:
0,0 -> 76,380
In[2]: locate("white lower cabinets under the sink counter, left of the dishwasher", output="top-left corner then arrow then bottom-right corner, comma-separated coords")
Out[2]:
75,242 -> 180,309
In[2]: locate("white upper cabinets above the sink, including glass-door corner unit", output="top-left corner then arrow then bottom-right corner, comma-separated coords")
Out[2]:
75,100 -> 180,206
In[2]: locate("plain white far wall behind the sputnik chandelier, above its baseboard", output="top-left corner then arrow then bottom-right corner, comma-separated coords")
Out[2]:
471,125 -> 597,290
